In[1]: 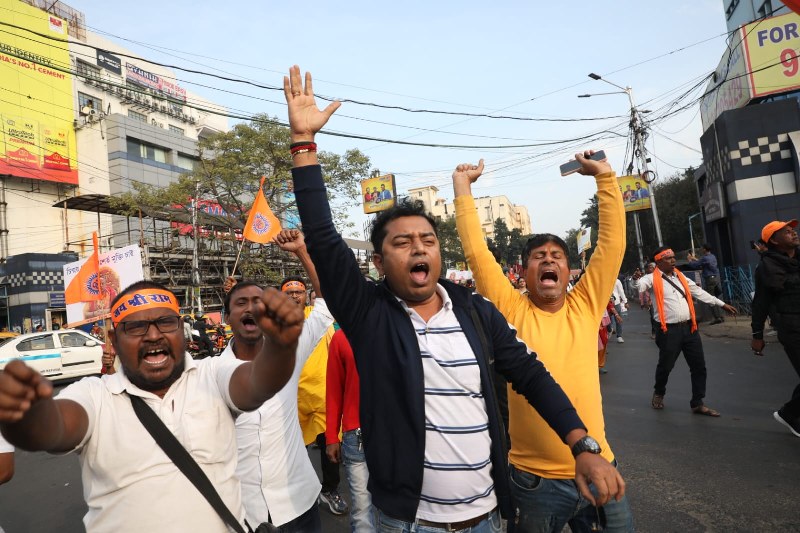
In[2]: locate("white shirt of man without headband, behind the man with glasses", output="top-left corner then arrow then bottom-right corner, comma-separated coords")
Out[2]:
220,298 -> 333,528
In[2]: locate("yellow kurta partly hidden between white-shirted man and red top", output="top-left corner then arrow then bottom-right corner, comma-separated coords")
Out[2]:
297,307 -> 335,446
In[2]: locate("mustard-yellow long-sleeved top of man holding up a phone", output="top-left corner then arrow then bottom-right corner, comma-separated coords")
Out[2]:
455,172 -> 625,479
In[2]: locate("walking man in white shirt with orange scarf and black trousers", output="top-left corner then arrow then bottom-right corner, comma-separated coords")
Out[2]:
639,246 -> 736,416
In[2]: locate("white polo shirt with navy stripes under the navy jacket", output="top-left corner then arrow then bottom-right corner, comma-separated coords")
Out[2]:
401,285 -> 497,522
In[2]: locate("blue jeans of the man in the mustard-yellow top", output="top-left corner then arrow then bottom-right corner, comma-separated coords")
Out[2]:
511,465 -> 633,533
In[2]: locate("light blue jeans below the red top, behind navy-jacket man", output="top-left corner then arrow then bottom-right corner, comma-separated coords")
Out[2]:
342,429 -> 375,533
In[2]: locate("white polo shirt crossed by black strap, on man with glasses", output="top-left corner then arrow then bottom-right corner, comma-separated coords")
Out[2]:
57,354 -> 244,533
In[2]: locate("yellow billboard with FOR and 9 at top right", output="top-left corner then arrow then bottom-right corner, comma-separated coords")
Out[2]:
744,13 -> 800,97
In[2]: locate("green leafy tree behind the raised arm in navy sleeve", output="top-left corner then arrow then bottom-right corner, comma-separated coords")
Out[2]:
111,115 -> 370,279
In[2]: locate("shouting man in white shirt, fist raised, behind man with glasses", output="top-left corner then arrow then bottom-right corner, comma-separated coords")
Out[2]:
220,230 -> 333,533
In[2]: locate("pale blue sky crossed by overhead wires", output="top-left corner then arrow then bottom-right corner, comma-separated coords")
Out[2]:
67,0 -> 726,236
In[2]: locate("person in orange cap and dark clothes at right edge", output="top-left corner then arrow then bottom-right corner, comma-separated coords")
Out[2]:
750,220 -> 800,437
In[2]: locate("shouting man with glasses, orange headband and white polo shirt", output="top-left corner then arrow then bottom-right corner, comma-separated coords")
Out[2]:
0,281 -> 303,533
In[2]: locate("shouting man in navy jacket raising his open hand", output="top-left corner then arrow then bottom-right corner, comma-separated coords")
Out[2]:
284,66 -> 625,532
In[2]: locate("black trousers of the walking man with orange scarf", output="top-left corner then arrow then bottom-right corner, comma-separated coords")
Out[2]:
654,322 -> 706,408
